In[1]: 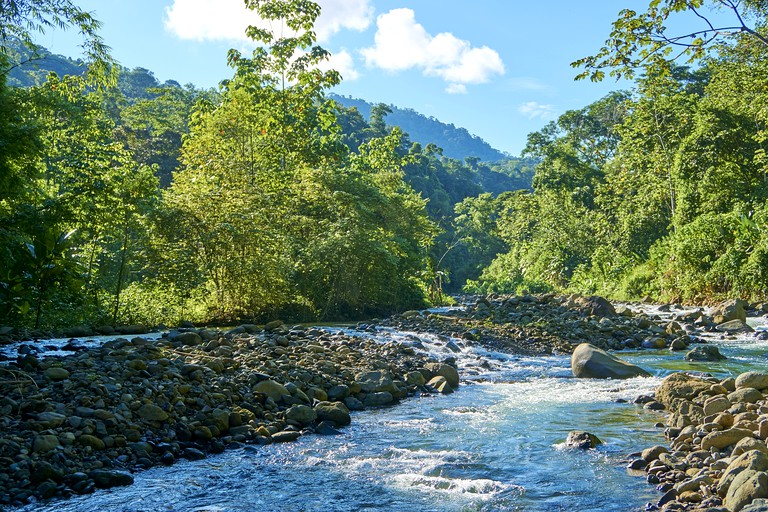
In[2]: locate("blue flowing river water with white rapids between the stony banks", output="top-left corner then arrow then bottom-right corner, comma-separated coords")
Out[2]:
13,306 -> 768,512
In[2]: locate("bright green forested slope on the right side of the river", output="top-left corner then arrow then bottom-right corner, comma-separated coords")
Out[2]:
467,2 -> 768,302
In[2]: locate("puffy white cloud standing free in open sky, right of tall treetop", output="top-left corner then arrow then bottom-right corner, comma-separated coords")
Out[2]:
361,9 -> 504,92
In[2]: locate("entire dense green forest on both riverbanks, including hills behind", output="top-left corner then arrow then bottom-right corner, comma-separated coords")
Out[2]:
0,0 -> 768,329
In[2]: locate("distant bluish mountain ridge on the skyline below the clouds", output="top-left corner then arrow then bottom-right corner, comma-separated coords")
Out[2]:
328,93 -> 509,162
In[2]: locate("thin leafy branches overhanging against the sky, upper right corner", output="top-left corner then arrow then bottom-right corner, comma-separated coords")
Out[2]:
571,0 -> 768,81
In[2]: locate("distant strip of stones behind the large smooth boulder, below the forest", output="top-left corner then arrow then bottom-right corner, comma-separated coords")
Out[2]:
384,294 -> 768,357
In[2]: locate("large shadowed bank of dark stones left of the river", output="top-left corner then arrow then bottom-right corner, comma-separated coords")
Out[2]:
0,322 -> 459,505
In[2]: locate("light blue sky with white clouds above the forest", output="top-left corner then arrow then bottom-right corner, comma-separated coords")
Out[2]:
39,0 -> 712,155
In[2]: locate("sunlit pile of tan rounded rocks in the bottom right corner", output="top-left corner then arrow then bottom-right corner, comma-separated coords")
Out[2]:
630,372 -> 768,512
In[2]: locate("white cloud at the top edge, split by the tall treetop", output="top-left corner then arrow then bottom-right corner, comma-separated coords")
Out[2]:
165,0 -> 373,43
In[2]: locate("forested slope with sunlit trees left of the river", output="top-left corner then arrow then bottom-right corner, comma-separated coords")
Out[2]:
0,4 -> 535,328
